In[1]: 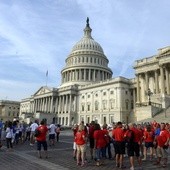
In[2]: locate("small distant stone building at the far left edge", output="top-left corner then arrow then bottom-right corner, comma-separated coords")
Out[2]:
0,100 -> 20,121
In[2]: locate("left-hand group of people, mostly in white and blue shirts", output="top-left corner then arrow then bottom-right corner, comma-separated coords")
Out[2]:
0,120 -> 61,158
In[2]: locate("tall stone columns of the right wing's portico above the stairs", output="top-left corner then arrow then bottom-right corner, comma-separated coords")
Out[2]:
136,65 -> 170,103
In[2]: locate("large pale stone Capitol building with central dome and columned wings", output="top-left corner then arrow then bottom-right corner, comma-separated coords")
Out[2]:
20,19 -> 170,126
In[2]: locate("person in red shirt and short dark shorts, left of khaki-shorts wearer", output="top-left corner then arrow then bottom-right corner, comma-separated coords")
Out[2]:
142,125 -> 155,161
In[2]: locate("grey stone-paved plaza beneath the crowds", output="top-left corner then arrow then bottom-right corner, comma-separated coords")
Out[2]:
0,130 -> 170,170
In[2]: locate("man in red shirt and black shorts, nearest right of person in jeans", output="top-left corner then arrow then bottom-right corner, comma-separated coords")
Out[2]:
112,122 -> 125,168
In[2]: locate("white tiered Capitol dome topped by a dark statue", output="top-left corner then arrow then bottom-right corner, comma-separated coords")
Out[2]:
61,18 -> 112,86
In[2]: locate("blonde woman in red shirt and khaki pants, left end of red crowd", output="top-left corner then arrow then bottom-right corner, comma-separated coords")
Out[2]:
75,124 -> 86,166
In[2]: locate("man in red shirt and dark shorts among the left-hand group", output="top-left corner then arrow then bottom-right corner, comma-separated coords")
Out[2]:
36,120 -> 48,158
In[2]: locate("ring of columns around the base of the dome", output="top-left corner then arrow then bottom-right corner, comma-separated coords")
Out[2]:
62,69 -> 112,83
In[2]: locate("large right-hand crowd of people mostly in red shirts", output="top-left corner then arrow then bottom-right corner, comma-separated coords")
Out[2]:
72,121 -> 170,170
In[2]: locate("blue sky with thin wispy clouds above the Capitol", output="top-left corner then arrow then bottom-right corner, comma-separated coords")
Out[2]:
0,0 -> 170,101
